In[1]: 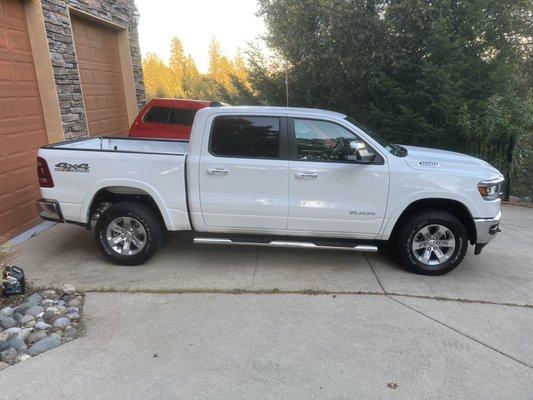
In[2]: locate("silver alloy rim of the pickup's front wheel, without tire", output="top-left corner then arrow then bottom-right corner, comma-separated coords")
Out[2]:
412,224 -> 455,265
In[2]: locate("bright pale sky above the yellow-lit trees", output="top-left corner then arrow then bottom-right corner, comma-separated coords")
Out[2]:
135,0 -> 265,73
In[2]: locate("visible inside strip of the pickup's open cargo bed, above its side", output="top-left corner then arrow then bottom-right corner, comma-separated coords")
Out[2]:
43,137 -> 189,155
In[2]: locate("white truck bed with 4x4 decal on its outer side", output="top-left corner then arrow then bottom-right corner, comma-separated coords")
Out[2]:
38,137 -> 190,230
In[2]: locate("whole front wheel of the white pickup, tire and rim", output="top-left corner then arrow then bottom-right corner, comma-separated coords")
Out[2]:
396,210 -> 468,275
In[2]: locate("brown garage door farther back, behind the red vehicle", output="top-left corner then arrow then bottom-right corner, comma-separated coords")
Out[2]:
71,15 -> 129,136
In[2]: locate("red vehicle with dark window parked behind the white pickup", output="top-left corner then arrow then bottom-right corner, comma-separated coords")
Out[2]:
129,99 -> 224,140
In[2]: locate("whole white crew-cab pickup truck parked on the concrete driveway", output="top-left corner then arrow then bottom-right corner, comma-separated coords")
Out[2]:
37,107 -> 503,275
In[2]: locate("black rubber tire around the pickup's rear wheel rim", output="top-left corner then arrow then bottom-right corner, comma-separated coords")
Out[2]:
94,201 -> 163,265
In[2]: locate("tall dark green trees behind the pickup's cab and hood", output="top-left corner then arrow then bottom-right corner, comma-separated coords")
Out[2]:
252,0 -> 533,193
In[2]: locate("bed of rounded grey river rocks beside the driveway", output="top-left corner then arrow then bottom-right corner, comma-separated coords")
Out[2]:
0,285 -> 83,371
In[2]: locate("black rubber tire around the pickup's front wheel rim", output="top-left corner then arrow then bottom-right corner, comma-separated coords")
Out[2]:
396,209 -> 468,275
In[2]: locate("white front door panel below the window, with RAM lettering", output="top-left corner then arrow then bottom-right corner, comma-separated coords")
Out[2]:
288,161 -> 389,238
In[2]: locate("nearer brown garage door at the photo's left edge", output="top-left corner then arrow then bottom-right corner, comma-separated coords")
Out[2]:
0,0 -> 47,241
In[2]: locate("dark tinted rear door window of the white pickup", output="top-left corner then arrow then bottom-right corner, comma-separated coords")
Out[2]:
210,116 -> 280,159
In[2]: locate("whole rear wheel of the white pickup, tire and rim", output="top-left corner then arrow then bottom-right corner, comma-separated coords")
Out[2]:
95,201 -> 163,265
